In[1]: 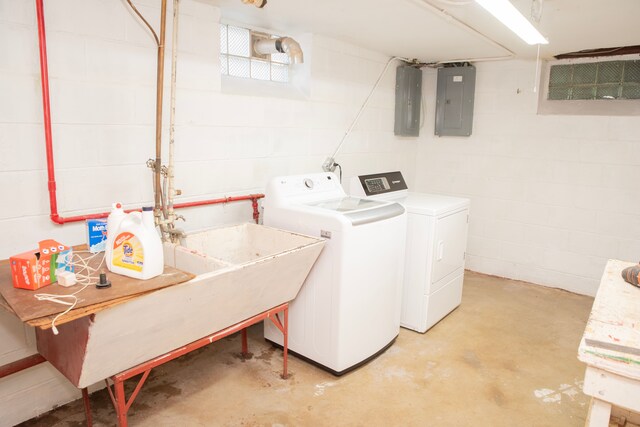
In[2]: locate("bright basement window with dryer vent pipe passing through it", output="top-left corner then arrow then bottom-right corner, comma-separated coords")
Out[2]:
220,24 -> 289,83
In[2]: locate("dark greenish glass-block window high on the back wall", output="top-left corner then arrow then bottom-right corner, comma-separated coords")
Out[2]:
548,60 -> 640,100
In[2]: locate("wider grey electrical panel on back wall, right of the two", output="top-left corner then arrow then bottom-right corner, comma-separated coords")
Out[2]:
435,65 -> 476,136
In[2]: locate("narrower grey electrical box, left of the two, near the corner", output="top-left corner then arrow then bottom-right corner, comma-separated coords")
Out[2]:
393,65 -> 422,136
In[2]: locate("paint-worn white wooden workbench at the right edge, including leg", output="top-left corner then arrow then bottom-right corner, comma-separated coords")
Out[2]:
578,260 -> 640,427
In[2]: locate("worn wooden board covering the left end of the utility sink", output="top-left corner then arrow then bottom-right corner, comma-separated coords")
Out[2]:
0,248 -> 195,329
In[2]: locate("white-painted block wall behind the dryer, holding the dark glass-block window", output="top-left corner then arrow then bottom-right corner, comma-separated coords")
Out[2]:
414,61 -> 640,295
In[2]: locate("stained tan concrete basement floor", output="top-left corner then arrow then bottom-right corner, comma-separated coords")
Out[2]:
21,272 -> 593,427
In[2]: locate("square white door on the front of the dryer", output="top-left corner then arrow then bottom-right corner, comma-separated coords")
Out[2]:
431,209 -> 469,283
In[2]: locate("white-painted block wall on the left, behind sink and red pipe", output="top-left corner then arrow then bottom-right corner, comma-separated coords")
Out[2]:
0,0 -> 416,426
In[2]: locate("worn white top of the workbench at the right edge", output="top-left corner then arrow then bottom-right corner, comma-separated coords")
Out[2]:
578,260 -> 640,380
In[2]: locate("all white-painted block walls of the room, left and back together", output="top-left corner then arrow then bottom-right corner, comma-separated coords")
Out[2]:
0,0 -> 640,425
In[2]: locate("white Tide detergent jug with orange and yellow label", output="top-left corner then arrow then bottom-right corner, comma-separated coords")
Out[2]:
105,203 -> 164,280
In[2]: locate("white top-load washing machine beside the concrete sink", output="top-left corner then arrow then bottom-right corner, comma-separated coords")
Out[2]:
262,173 -> 407,375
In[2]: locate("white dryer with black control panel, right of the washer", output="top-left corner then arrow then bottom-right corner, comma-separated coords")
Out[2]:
350,172 -> 469,332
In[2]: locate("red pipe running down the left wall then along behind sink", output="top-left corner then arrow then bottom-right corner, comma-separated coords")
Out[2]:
36,0 -> 264,224
